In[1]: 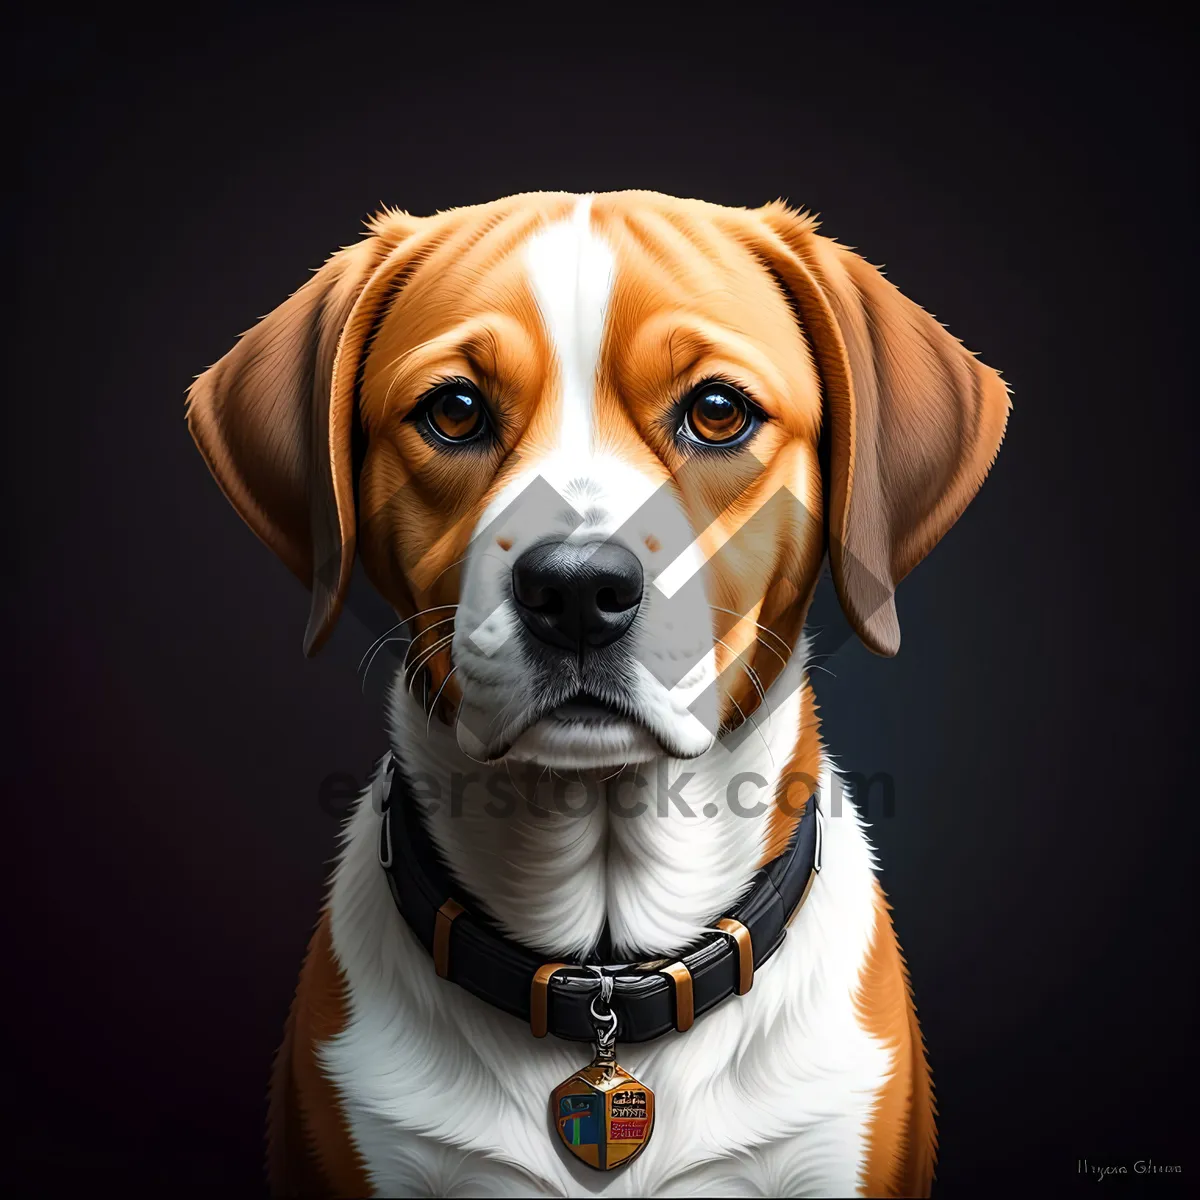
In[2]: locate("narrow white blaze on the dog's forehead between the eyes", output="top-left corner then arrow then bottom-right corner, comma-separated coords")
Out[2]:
526,196 -> 616,454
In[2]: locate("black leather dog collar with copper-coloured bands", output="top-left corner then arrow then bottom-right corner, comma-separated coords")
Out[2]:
371,751 -> 822,1042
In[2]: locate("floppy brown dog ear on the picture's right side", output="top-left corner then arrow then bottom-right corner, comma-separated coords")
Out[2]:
724,202 -> 1009,656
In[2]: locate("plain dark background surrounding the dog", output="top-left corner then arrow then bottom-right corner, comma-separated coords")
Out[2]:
2,4 -> 1198,1195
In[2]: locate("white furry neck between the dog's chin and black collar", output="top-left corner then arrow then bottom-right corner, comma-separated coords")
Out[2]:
389,640 -> 820,960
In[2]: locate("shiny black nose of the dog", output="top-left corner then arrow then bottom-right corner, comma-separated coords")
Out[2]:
512,541 -> 642,654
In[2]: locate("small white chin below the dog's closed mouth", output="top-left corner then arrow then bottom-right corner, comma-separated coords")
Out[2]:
504,704 -> 664,770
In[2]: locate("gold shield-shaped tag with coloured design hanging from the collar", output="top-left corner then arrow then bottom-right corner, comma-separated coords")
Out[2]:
550,1040 -> 654,1171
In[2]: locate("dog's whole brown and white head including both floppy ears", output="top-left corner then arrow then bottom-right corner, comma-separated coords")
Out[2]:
188,192 -> 1008,768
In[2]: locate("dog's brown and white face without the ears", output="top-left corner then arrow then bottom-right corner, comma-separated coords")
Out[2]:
350,190 -> 821,767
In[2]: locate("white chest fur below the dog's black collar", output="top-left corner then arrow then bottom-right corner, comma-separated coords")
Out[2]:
319,739 -> 890,1196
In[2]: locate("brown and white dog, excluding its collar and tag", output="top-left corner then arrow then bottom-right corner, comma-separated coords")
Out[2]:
188,192 -> 1009,1196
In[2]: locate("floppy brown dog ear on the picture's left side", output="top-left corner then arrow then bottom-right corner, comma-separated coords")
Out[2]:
187,212 -> 420,654
